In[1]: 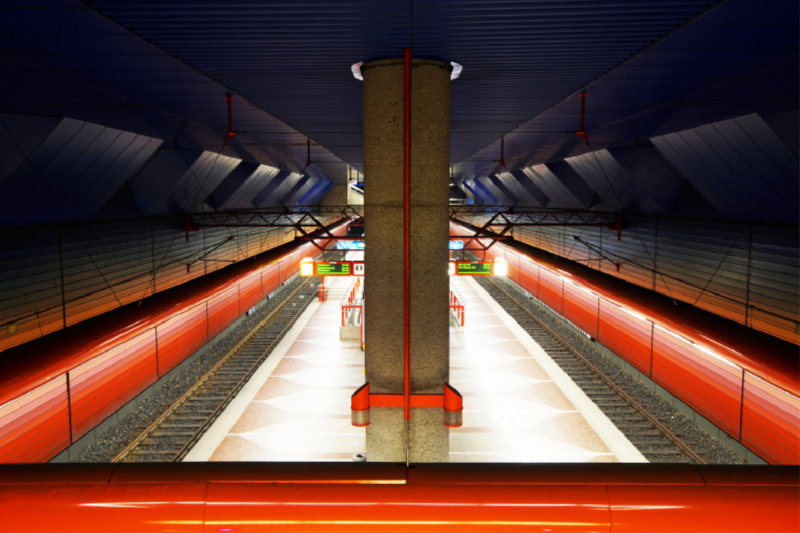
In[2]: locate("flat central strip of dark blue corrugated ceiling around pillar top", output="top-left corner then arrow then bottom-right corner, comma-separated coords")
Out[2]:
79,0 -> 724,168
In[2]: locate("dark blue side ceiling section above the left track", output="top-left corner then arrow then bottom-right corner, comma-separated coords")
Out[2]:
0,1 -> 344,189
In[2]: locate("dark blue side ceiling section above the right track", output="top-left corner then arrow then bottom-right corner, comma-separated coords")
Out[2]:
455,0 -> 800,181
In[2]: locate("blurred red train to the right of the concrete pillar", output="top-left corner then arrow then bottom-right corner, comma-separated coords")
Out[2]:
451,219 -> 800,464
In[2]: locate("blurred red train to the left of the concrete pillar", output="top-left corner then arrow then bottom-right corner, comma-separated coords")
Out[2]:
0,225 -> 347,463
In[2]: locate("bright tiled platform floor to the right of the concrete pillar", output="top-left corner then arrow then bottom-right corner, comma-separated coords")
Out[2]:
450,277 -> 641,463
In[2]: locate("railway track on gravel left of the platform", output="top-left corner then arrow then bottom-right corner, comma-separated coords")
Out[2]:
112,278 -> 317,463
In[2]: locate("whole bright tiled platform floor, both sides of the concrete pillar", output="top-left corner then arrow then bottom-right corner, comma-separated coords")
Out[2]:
186,278 -> 644,462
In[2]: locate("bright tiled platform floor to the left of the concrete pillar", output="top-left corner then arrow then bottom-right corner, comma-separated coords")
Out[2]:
186,278 -> 366,461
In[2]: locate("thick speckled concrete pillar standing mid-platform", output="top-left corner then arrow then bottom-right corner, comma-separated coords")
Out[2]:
361,56 -> 451,462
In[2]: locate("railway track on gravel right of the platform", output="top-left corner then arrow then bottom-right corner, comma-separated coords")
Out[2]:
478,278 -> 705,464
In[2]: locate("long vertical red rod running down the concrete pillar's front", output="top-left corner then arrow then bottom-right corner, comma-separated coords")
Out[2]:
403,48 -> 411,420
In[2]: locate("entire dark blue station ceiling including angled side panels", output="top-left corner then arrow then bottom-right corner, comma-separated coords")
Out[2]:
0,0 -> 800,223
